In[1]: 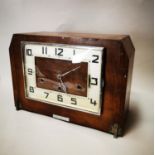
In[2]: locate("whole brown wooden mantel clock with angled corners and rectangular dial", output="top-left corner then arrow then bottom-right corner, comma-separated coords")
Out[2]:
10,32 -> 134,137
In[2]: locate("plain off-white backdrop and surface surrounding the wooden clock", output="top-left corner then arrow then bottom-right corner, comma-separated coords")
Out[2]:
0,0 -> 153,155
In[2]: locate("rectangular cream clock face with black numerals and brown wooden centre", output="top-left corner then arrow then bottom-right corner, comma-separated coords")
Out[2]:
21,42 -> 103,115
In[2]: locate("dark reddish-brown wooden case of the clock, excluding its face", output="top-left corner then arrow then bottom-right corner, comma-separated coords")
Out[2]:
10,32 -> 134,136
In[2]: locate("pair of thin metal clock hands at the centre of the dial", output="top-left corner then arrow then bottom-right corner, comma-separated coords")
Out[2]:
57,66 -> 80,93
